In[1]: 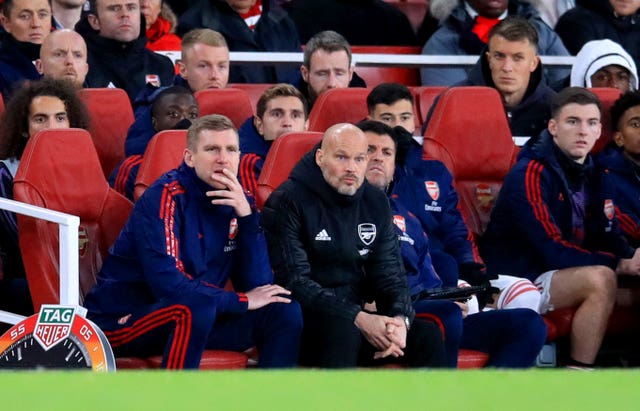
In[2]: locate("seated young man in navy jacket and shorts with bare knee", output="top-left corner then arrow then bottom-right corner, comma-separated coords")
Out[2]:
482,87 -> 640,367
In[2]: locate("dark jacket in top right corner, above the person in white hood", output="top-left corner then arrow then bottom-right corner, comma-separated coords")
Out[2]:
555,0 -> 640,67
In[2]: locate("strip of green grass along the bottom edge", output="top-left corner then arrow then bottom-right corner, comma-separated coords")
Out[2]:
0,370 -> 640,411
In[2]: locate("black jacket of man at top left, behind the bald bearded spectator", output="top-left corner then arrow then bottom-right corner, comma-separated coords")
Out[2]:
75,16 -> 175,101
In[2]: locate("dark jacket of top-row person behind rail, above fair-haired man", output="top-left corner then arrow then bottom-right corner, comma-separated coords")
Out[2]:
177,0 -> 302,83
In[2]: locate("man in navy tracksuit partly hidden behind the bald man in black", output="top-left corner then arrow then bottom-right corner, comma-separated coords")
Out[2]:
358,121 -> 547,367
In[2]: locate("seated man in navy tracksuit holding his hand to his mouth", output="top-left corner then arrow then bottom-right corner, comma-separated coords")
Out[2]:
85,115 -> 302,369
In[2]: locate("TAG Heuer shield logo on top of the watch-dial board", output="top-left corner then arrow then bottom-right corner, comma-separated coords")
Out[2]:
33,305 -> 76,351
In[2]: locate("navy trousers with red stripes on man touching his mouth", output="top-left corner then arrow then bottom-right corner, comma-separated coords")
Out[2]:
89,295 -> 302,369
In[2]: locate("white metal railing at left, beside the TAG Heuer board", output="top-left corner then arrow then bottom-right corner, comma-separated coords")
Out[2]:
0,198 -> 80,324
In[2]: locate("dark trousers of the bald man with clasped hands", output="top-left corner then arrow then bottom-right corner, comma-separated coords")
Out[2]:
300,311 -> 446,368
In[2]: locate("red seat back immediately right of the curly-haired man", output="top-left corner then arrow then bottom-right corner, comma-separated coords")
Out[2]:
79,88 -> 133,177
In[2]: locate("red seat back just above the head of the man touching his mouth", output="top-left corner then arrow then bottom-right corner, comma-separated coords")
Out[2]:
195,88 -> 253,128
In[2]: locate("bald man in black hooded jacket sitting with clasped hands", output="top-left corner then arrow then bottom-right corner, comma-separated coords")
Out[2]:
263,124 -> 445,368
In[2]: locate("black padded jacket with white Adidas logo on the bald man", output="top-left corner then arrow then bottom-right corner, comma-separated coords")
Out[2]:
263,150 -> 414,326
